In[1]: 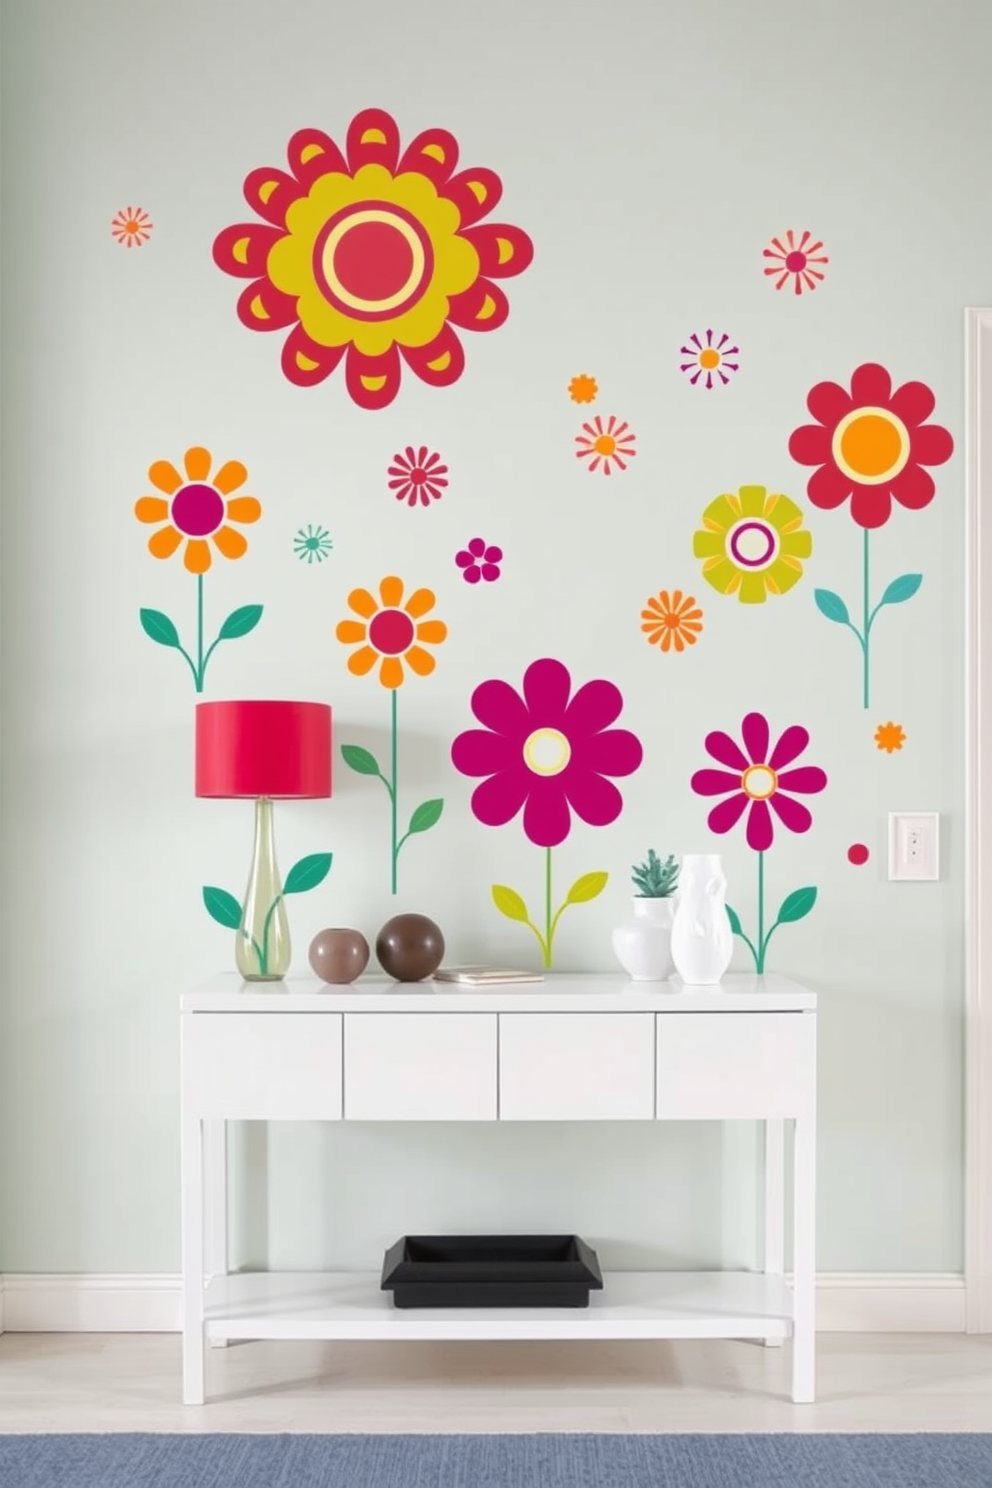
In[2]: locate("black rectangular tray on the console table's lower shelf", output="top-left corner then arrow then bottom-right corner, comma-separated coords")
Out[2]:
382,1235 -> 602,1308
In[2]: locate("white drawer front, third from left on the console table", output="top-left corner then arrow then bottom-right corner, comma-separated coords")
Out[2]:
500,1013 -> 654,1120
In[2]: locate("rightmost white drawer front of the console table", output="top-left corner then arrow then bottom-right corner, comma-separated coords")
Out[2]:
656,1012 -> 817,1120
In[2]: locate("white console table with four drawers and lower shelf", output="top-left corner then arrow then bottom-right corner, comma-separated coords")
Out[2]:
180,975 -> 817,1405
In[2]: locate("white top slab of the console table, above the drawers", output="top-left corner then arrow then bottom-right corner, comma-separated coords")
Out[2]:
180,972 -> 817,1013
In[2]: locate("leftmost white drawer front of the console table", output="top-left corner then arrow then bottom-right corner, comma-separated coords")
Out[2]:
183,1013 -> 341,1120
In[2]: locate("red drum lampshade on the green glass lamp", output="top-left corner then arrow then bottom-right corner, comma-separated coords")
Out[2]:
196,699 -> 330,798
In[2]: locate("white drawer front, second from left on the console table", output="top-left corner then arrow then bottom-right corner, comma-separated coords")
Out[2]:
345,1012 -> 497,1120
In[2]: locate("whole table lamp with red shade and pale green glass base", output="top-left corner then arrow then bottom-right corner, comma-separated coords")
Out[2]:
196,699 -> 330,982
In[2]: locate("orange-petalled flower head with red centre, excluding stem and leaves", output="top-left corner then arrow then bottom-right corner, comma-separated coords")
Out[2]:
336,576 -> 448,690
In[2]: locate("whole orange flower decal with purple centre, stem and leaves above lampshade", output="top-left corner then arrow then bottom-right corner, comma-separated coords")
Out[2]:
134,445 -> 262,692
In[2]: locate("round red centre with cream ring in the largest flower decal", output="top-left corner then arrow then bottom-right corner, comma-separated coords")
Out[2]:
314,201 -> 434,320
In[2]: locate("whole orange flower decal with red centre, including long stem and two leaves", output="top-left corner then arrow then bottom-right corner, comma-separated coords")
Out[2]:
336,574 -> 448,893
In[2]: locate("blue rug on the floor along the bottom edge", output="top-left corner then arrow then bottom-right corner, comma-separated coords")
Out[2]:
0,1433 -> 992,1488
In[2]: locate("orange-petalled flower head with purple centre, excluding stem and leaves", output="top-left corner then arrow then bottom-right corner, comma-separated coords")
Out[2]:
134,445 -> 262,573
